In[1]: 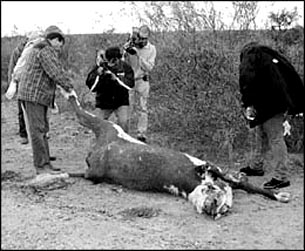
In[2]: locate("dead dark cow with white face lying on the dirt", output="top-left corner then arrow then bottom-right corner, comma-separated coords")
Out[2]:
62,90 -> 289,219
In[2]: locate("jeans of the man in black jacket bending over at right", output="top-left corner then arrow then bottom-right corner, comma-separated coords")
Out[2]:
249,113 -> 288,178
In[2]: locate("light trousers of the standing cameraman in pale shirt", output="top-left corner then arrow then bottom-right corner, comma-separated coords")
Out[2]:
129,79 -> 150,135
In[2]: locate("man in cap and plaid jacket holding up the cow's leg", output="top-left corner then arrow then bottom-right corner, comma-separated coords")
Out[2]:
17,26 -> 73,174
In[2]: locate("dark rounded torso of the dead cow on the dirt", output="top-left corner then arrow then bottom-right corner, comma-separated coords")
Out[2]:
87,142 -> 201,194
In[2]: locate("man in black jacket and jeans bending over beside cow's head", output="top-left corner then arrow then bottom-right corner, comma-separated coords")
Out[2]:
239,42 -> 304,189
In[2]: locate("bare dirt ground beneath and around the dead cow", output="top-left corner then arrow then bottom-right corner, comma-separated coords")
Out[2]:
1,98 -> 304,250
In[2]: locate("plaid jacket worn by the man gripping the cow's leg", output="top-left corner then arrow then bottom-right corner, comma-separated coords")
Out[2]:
17,40 -> 72,107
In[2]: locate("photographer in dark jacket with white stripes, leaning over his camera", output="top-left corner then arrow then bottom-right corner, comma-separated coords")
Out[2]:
86,46 -> 134,133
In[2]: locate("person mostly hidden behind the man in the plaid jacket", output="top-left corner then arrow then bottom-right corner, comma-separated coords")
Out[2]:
7,38 -> 29,144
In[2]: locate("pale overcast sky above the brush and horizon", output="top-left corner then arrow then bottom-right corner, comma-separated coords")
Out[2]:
1,1 -> 304,37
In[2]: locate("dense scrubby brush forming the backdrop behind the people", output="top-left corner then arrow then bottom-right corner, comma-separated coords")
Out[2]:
1,31 -> 304,161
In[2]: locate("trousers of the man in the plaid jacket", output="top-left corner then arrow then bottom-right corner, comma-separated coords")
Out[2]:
22,101 -> 50,168
